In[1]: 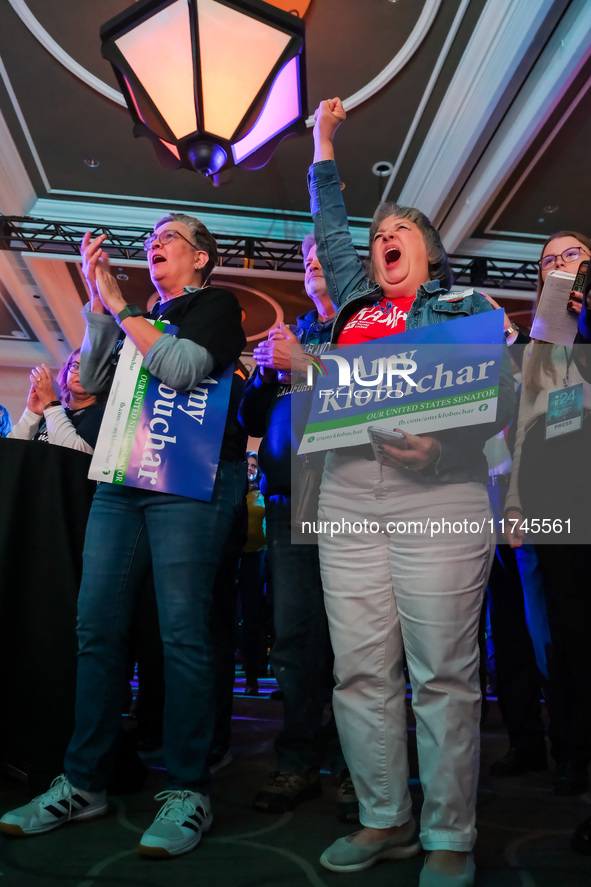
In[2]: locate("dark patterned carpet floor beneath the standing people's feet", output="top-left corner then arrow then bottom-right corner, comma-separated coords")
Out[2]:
0,696 -> 591,887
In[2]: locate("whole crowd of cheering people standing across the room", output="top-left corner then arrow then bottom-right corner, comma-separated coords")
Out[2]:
0,99 -> 591,887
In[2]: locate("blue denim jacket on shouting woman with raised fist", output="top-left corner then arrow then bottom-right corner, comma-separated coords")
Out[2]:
308,160 -> 516,483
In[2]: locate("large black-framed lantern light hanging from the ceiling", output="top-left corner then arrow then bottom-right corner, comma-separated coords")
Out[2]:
101,0 -> 308,181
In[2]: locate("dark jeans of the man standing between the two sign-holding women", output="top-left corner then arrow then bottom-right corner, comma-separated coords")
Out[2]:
265,496 -> 345,773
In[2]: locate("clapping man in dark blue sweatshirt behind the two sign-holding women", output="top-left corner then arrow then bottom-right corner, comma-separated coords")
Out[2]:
240,236 -> 358,822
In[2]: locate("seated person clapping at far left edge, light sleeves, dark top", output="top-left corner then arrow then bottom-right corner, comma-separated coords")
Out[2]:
7,348 -> 105,454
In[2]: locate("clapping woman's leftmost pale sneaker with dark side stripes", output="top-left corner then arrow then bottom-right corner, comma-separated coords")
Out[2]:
0,773 -> 107,837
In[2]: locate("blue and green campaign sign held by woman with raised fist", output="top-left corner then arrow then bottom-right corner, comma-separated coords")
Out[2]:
298,310 -> 503,453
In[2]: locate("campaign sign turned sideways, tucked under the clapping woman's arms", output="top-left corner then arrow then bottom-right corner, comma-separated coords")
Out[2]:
88,321 -> 234,502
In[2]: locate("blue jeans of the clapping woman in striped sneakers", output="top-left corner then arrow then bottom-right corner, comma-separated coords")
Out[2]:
65,462 -> 246,792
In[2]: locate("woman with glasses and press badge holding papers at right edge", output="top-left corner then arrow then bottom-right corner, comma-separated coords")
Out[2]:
505,231 -> 591,795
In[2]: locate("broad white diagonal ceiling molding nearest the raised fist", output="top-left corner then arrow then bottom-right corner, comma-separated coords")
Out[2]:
399,0 -> 567,225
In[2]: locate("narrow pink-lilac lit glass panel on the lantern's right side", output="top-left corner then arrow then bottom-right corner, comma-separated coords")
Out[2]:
232,58 -> 301,163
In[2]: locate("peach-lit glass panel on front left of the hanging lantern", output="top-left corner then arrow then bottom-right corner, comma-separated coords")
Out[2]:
115,0 -> 197,139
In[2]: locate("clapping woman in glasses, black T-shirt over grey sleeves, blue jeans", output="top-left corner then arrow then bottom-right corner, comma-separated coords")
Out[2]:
0,213 -> 246,858
